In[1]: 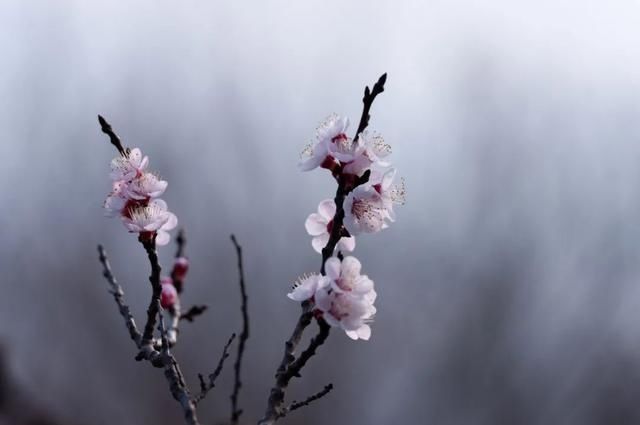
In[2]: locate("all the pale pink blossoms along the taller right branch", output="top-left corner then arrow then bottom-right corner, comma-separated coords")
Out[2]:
288,115 -> 405,340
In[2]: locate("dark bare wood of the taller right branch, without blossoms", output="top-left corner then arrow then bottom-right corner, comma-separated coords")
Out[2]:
259,74 -> 387,425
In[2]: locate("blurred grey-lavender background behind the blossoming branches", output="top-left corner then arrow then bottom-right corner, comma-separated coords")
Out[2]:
0,0 -> 640,425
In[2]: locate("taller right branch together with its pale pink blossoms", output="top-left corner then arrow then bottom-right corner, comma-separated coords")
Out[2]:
259,74 -> 391,425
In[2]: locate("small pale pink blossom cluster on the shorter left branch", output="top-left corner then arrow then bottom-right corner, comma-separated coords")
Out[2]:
104,148 -> 178,245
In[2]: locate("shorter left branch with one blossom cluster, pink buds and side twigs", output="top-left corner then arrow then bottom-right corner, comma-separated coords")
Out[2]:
98,116 -> 235,425
